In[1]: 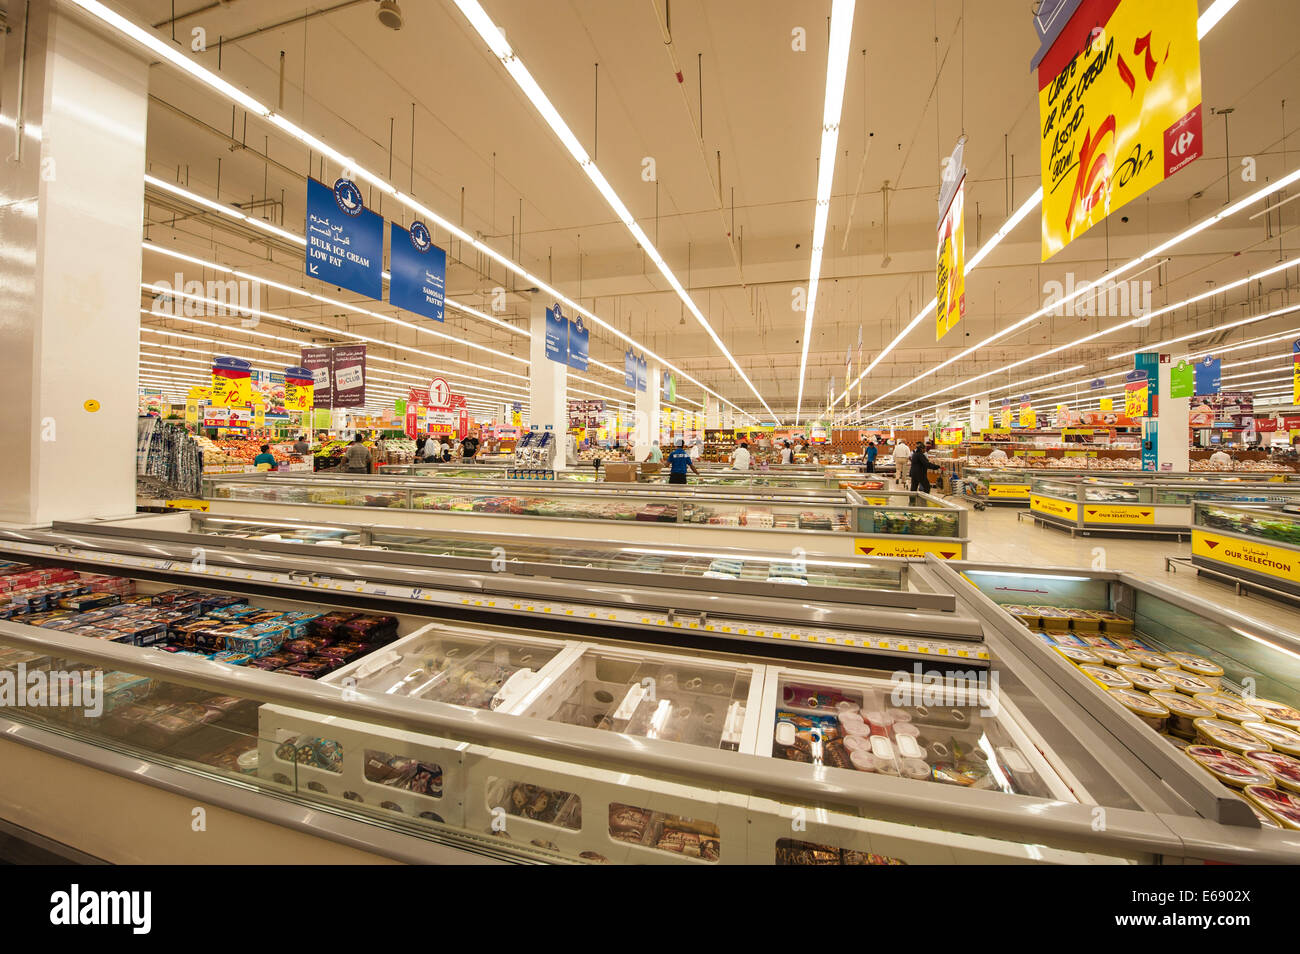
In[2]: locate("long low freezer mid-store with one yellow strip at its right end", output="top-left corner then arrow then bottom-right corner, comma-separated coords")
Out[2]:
204,474 -> 966,559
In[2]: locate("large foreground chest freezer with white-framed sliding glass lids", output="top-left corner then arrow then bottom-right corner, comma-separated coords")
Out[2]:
0,527 -> 1300,864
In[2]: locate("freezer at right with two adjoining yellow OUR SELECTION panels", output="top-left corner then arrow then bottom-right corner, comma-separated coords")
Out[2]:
1030,477 -> 1300,538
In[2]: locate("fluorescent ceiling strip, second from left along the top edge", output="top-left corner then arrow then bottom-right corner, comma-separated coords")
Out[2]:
454,0 -> 769,417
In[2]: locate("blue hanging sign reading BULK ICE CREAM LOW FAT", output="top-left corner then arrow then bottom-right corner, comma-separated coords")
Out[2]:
304,178 -> 384,300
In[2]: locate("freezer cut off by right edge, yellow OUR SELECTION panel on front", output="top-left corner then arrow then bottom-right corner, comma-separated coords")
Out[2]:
1192,499 -> 1300,600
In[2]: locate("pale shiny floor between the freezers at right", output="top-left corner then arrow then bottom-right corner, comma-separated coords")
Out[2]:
953,499 -> 1300,633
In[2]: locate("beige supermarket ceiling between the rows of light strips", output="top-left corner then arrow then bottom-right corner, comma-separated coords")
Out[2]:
109,0 -> 1300,421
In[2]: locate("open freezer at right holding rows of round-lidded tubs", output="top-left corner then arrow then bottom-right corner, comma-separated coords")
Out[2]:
951,564 -> 1300,837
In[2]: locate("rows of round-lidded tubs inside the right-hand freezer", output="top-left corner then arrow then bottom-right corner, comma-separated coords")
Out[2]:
1004,604 -> 1300,831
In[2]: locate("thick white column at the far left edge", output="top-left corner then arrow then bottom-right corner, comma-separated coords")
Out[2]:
0,0 -> 148,525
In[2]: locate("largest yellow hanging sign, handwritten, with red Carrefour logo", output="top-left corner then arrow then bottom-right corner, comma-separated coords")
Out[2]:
1039,0 -> 1204,261
